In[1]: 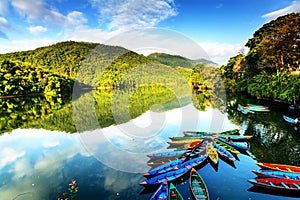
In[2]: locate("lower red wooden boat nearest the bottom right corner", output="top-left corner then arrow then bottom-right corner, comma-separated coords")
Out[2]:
248,178 -> 300,192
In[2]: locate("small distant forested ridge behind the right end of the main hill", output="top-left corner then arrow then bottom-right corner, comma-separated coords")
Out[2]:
148,53 -> 218,69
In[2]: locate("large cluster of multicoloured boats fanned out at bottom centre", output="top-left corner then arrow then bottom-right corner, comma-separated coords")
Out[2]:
140,129 -> 252,200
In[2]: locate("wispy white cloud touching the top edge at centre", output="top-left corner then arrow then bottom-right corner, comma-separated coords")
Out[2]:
90,0 -> 177,30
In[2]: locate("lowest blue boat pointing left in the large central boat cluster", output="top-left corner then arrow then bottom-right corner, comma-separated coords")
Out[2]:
140,167 -> 191,185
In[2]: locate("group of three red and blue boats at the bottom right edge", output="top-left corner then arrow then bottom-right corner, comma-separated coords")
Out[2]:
248,163 -> 300,192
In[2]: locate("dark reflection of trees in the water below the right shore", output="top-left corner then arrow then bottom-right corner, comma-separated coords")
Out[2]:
227,97 -> 300,166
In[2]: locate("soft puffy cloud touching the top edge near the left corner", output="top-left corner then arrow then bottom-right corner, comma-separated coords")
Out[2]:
11,0 -> 64,24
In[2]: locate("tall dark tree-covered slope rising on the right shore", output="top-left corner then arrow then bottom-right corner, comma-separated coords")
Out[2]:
220,13 -> 300,103
